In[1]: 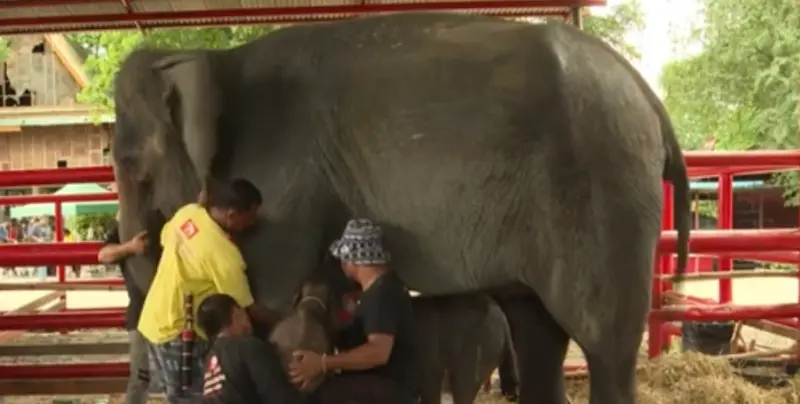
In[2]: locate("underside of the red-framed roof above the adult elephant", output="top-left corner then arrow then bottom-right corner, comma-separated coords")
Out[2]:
0,0 -> 606,35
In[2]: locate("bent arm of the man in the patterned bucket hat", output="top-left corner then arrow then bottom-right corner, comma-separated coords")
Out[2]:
325,290 -> 400,371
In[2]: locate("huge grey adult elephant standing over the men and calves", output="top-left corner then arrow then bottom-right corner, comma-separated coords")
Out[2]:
113,13 -> 690,404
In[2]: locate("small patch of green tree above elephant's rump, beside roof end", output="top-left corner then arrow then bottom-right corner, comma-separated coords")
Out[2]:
583,0 -> 644,60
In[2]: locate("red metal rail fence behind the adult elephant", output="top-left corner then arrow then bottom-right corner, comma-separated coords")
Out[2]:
0,151 -> 800,379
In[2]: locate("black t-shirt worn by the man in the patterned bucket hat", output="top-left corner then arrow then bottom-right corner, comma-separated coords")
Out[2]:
338,272 -> 418,395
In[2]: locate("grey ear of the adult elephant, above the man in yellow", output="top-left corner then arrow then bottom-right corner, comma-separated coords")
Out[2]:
153,52 -> 223,193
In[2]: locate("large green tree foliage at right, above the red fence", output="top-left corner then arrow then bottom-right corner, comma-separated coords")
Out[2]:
662,0 -> 800,150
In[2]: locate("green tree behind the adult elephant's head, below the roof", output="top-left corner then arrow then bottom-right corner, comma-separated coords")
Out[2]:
69,27 -> 273,112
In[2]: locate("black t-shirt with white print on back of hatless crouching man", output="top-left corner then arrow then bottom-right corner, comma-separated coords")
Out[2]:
203,336 -> 300,404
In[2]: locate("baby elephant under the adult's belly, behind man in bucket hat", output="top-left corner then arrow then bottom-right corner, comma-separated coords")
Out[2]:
413,294 -> 516,404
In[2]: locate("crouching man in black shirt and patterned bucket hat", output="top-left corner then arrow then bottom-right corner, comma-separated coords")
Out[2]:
289,219 -> 417,404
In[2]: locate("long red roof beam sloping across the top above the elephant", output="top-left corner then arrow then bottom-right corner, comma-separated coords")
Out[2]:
0,0 -> 605,27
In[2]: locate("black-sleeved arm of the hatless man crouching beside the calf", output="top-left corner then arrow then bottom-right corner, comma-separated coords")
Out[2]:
242,338 -> 299,404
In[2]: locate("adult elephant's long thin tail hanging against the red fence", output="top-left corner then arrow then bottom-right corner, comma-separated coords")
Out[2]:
661,115 -> 692,284
